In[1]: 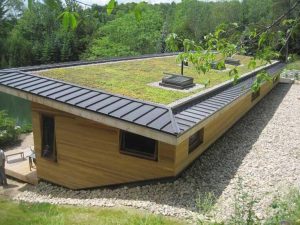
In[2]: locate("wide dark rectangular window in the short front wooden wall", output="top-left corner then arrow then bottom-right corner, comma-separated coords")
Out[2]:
120,131 -> 157,160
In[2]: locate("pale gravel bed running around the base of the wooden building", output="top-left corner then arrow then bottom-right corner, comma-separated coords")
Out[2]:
6,84 -> 300,223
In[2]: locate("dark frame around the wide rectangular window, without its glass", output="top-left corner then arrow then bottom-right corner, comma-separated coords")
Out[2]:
119,131 -> 158,161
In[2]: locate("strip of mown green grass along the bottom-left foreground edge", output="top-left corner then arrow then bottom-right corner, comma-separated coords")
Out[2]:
0,198 -> 183,225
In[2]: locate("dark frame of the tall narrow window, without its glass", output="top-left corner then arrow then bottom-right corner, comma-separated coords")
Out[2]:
40,113 -> 57,162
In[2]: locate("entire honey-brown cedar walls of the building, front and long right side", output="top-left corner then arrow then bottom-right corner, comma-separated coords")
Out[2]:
32,76 -> 277,189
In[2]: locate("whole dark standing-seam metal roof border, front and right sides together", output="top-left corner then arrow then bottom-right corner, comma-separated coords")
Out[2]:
0,58 -> 284,136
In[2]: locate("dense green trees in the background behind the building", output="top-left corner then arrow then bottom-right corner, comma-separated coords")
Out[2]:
0,0 -> 300,68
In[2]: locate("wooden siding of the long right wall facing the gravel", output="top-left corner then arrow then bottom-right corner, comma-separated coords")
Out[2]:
174,80 -> 278,175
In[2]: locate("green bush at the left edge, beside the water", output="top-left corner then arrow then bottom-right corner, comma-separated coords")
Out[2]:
0,111 -> 21,147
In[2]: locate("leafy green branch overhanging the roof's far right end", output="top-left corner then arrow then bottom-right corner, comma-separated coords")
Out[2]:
166,2 -> 300,92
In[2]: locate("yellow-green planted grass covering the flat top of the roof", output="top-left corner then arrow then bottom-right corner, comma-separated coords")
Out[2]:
38,56 -> 260,104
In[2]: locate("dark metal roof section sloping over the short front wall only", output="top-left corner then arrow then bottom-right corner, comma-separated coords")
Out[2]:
0,70 -> 179,135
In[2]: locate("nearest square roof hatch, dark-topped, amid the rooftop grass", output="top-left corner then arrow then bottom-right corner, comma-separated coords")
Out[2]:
159,73 -> 195,89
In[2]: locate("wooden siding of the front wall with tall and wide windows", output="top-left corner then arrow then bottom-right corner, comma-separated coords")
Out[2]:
32,103 -> 176,189
